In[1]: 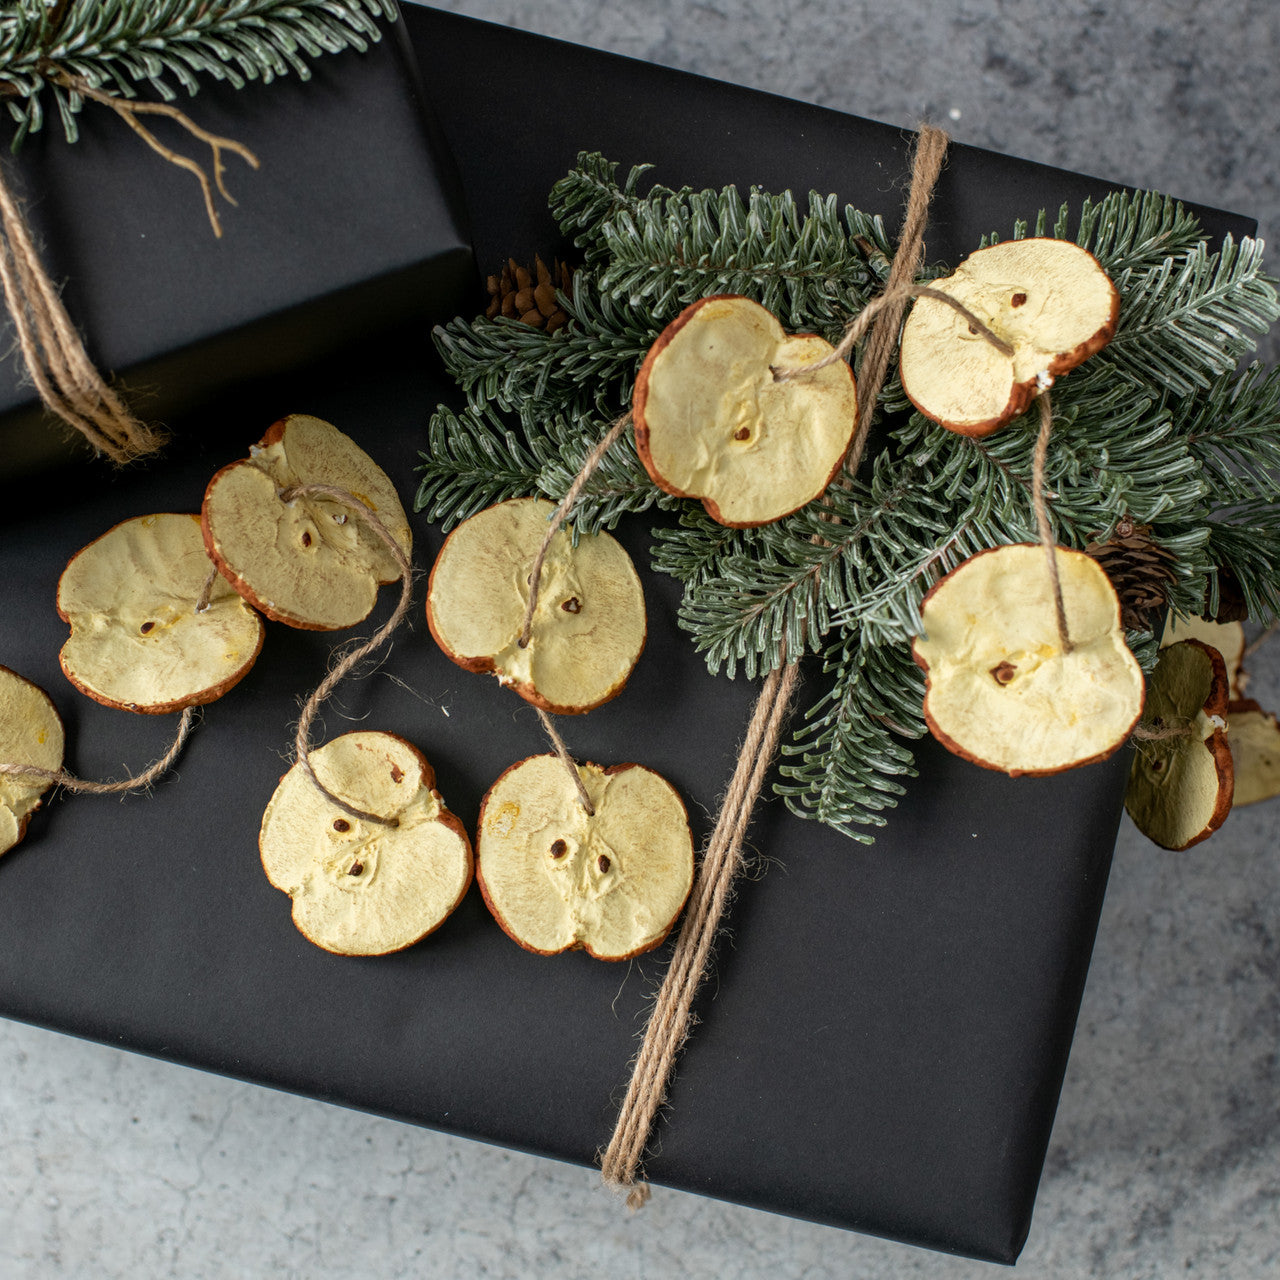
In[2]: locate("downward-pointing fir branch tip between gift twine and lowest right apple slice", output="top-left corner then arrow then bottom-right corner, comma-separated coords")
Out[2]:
773,635 -> 925,845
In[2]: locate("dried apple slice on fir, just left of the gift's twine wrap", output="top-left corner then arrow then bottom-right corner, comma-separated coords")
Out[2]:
631,294 -> 858,529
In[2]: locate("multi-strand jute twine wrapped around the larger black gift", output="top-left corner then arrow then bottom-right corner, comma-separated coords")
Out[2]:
600,125 -> 947,1208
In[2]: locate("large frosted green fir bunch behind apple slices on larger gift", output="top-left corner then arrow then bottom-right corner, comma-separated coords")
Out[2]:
419,154 -> 1280,840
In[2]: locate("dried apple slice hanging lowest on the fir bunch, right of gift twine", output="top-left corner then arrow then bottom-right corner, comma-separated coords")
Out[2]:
914,544 -> 1143,777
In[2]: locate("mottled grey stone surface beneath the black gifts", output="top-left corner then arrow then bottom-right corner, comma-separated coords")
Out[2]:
0,0 -> 1280,1280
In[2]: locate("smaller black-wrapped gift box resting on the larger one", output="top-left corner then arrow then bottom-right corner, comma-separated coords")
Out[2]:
0,12 -> 472,484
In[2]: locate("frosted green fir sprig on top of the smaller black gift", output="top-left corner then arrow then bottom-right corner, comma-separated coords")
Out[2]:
0,0 -> 396,146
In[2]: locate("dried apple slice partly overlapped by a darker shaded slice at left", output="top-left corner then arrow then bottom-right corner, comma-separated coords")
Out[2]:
58,513 -> 262,716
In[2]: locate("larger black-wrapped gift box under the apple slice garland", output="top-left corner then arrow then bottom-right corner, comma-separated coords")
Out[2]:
0,0 -> 1249,1261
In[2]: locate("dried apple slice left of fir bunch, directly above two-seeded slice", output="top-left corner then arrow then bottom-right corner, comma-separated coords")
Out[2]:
426,498 -> 645,716
